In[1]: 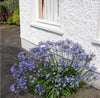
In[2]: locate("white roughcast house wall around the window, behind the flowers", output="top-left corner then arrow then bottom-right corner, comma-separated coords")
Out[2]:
20,0 -> 100,72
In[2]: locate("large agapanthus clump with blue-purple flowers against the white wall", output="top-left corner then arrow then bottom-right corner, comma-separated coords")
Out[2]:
10,39 -> 96,98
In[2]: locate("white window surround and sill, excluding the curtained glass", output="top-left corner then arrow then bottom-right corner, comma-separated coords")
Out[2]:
30,0 -> 63,35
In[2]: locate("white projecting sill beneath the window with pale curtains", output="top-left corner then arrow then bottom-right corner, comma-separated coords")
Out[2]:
30,22 -> 63,35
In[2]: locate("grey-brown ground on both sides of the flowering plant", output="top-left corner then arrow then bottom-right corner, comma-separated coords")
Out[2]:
0,27 -> 100,98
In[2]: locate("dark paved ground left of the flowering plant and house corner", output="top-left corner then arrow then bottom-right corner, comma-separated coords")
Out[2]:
0,27 -> 22,98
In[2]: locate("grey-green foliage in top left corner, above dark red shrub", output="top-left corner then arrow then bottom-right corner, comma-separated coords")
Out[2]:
1,0 -> 19,13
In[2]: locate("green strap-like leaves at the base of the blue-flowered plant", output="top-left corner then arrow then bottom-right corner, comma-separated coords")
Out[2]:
28,65 -> 85,98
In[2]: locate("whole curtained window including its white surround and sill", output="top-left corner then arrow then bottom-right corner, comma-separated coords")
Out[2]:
31,0 -> 64,35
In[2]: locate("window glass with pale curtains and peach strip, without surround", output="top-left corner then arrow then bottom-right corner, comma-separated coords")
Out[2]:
38,0 -> 60,24
